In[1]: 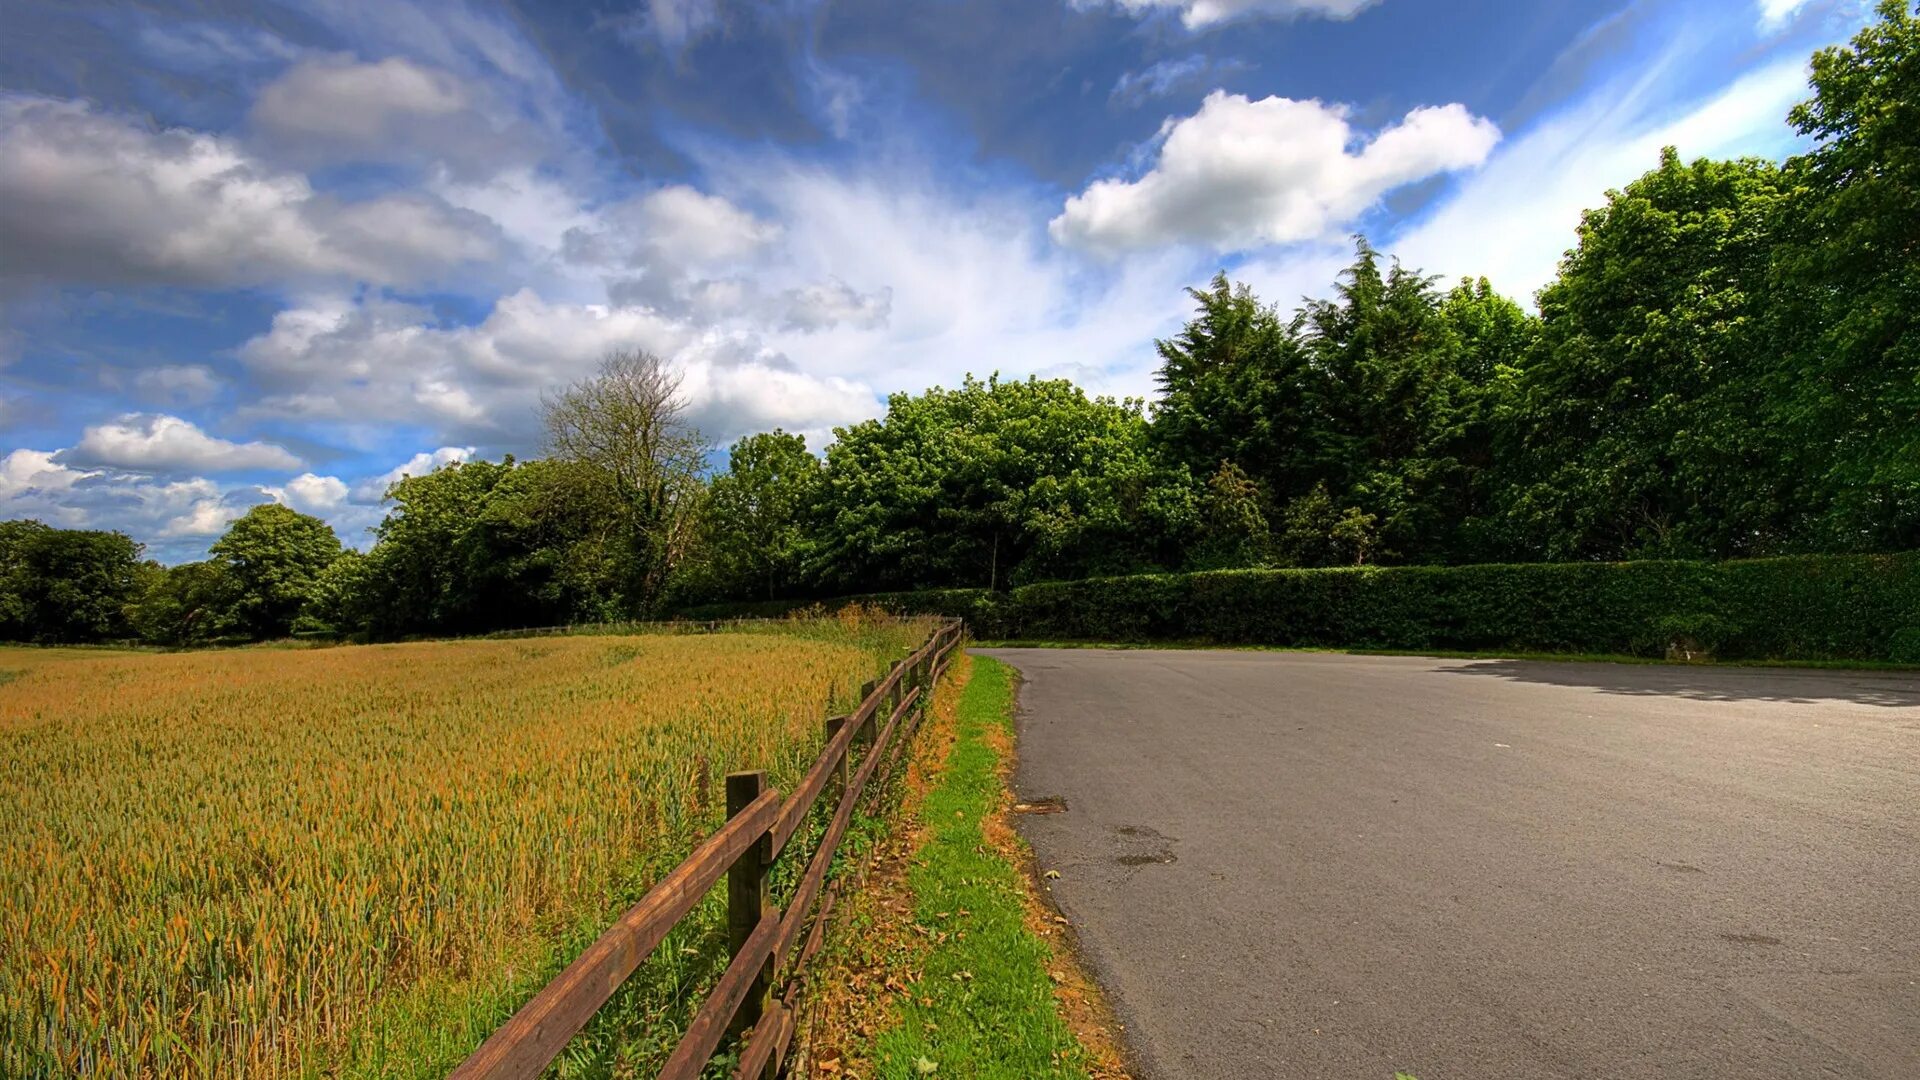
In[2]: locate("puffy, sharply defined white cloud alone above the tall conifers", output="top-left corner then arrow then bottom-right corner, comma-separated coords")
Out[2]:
1048,90 -> 1500,254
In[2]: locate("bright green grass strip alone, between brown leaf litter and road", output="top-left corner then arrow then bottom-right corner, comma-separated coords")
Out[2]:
874,645 -> 1087,1080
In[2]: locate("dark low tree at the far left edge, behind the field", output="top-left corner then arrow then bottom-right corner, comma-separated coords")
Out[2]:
0,521 -> 142,642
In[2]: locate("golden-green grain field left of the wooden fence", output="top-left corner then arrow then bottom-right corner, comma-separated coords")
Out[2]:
0,619 -> 924,1076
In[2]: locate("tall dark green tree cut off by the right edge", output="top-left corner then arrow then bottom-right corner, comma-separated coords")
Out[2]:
1770,0 -> 1920,550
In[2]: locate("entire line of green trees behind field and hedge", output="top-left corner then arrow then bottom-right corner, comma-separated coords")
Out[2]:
11,8 -> 1920,642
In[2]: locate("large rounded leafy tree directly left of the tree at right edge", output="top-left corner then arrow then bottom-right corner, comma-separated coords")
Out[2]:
1496,150 -> 1801,559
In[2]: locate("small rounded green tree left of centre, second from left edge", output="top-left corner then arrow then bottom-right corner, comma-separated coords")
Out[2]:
211,503 -> 340,640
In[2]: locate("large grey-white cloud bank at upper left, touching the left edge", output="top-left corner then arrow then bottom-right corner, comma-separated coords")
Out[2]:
0,94 -> 499,284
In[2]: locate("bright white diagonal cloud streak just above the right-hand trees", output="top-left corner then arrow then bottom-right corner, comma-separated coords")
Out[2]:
1384,58 -> 1807,300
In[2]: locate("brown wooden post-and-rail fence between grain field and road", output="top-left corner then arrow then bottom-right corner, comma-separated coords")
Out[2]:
453,619 -> 962,1080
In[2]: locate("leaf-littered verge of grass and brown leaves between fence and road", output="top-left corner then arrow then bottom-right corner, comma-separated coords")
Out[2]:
816,657 -> 1125,1080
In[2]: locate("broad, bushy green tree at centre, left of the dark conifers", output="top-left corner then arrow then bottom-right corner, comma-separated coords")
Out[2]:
814,377 -> 1194,590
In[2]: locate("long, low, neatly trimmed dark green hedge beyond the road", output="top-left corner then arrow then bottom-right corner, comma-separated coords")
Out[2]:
672,553 -> 1920,661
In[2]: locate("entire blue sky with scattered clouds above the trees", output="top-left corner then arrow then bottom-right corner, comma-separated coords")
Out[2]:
0,0 -> 1866,563
